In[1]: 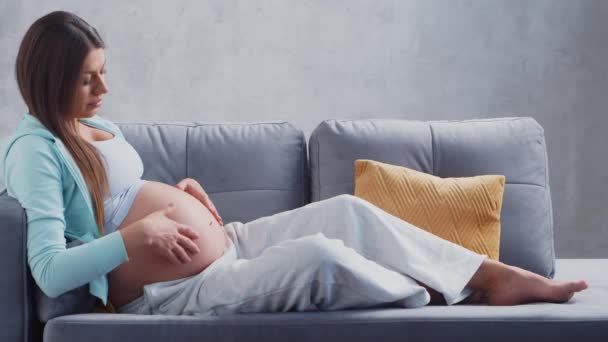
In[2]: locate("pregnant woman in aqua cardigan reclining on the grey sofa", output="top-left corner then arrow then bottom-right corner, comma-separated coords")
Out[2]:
1,11 -> 587,315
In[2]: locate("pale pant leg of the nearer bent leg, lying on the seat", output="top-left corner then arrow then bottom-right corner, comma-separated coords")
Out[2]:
176,233 -> 430,315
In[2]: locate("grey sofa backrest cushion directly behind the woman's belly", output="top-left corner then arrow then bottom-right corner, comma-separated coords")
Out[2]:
116,121 -> 309,224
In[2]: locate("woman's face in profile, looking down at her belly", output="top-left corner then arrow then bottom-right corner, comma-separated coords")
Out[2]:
70,48 -> 108,118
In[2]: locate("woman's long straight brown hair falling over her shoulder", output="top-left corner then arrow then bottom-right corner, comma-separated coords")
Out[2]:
15,11 -> 108,235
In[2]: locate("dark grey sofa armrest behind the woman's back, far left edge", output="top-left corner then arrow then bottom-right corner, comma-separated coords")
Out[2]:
0,190 -> 41,342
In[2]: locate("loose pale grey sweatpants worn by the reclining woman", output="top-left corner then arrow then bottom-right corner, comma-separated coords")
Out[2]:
117,195 -> 487,315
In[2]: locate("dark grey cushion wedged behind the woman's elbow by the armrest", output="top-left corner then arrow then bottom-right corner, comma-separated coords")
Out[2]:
34,240 -> 97,323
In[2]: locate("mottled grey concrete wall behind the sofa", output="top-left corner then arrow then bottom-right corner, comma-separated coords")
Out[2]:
0,0 -> 608,258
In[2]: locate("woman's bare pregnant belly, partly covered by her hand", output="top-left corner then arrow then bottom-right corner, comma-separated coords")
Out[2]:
108,181 -> 228,308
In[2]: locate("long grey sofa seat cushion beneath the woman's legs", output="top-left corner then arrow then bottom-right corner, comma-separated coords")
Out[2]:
44,259 -> 608,342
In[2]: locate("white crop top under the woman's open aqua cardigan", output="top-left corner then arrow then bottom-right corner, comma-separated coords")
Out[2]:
91,135 -> 145,235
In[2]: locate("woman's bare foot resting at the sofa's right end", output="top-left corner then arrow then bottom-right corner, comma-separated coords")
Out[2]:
481,264 -> 587,305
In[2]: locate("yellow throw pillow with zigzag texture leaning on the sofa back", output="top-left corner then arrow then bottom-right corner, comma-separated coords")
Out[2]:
355,159 -> 505,260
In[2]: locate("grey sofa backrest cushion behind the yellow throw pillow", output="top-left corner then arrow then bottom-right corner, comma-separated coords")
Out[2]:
309,117 -> 555,277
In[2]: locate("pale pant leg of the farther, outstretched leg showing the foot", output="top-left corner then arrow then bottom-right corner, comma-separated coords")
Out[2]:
226,195 -> 487,305
